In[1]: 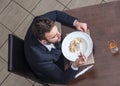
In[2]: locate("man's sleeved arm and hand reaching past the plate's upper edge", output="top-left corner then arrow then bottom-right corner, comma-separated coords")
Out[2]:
35,10 -> 87,32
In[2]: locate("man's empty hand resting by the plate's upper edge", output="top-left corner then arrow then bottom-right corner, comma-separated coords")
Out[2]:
74,20 -> 87,32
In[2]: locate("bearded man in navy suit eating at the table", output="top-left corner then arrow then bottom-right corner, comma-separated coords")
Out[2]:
24,11 -> 87,83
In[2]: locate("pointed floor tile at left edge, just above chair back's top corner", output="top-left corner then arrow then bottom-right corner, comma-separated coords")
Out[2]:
0,24 -> 11,47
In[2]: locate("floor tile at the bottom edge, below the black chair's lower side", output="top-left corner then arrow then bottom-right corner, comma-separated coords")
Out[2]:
1,73 -> 32,86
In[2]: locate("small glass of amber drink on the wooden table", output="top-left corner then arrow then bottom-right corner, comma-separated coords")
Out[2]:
108,40 -> 119,54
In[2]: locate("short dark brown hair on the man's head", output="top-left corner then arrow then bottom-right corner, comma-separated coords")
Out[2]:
32,18 -> 54,40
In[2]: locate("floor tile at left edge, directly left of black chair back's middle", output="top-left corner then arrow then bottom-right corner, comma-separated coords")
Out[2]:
0,41 -> 8,62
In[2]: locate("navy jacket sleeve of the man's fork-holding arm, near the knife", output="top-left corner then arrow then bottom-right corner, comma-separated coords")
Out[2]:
29,46 -> 78,83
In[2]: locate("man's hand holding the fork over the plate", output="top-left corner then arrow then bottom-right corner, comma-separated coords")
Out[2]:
72,54 -> 87,68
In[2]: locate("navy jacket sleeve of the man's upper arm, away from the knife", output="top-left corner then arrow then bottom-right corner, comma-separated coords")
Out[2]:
35,10 -> 77,27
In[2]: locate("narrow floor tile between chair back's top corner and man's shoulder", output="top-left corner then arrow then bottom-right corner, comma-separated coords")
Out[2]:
15,15 -> 34,39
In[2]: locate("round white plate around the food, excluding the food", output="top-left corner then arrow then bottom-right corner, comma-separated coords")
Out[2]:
62,31 -> 93,61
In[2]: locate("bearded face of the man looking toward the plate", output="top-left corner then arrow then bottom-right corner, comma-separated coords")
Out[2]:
45,25 -> 61,43
